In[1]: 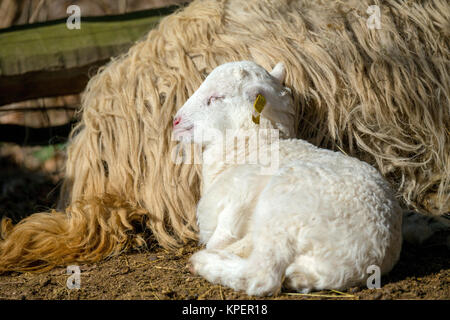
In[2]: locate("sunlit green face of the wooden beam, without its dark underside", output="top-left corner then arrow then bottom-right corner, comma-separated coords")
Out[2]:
0,17 -> 160,76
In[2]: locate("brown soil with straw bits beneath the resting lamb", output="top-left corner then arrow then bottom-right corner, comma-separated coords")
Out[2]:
0,240 -> 450,300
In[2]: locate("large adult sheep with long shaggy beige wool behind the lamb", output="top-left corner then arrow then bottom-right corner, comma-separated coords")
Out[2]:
0,0 -> 450,271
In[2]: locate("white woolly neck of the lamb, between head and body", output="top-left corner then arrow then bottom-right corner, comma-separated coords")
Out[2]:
202,129 -> 278,190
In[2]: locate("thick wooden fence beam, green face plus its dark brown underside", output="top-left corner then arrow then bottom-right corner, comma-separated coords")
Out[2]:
0,6 -> 178,106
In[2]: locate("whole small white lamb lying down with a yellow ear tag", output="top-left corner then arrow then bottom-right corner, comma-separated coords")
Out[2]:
173,61 -> 402,296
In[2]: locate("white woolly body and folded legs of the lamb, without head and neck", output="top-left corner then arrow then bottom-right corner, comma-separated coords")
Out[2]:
192,132 -> 401,295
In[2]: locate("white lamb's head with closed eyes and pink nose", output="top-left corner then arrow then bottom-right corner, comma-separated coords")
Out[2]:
173,61 -> 295,143
